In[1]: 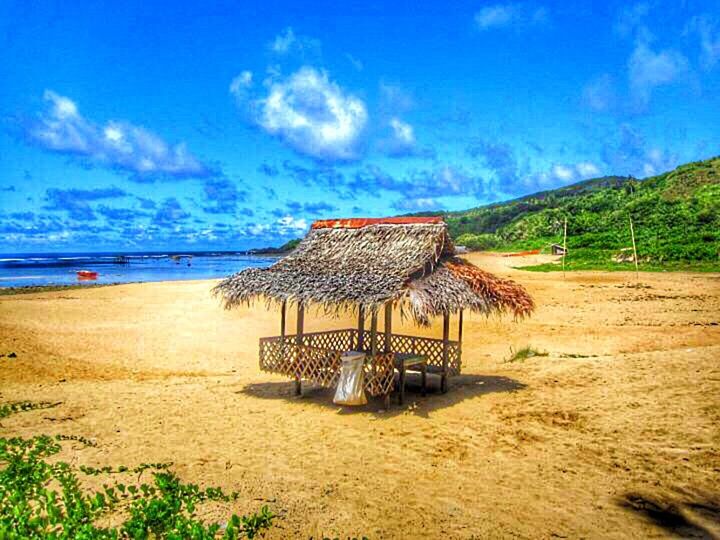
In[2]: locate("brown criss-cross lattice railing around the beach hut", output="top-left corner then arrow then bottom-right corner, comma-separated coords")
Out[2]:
260,329 -> 460,396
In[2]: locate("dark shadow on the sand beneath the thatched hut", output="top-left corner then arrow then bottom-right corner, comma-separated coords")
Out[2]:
237,373 -> 526,418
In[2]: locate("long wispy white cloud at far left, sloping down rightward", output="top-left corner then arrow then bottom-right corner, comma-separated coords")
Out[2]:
27,90 -> 213,179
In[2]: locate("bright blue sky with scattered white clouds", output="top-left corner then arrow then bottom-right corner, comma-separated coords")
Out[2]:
0,0 -> 720,252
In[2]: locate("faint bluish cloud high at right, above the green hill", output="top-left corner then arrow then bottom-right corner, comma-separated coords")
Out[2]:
628,38 -> 688,108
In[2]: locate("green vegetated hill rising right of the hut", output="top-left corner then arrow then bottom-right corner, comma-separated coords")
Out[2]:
436,157 -> 720,270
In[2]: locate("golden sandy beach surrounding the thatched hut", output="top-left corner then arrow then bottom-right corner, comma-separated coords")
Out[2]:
0,254 -> 720,538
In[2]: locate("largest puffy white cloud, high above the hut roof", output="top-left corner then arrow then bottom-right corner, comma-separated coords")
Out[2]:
257,66 -> 368,161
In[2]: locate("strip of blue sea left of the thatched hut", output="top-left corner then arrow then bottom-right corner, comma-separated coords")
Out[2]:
0,251 -> 278,287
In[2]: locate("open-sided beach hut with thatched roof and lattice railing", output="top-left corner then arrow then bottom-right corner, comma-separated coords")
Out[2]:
214,217 -> 534,406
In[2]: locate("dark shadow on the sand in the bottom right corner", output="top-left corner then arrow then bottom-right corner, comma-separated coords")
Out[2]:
618,493 -> 720,539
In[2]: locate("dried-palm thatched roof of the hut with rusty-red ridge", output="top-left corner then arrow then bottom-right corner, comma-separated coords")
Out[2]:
215,218 -> 534,325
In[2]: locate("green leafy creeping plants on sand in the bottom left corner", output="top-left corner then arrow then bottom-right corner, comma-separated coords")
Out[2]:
0,435 -> 275,540
